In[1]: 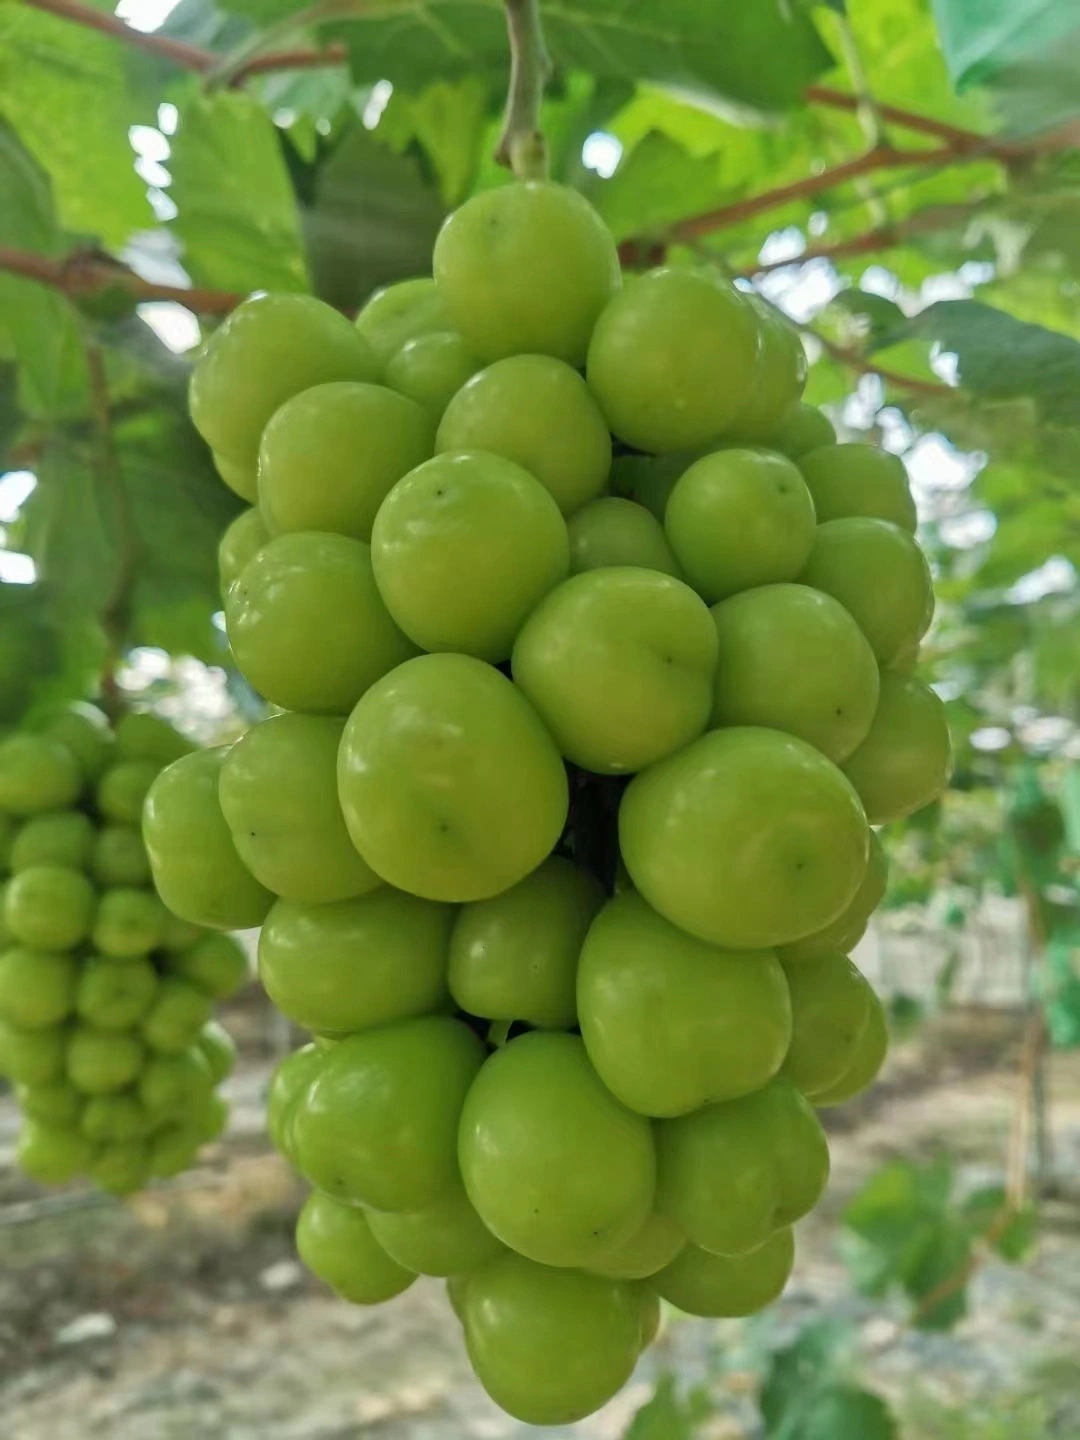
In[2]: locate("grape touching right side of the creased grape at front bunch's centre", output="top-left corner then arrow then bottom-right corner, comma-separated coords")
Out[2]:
713,585 -> 880,763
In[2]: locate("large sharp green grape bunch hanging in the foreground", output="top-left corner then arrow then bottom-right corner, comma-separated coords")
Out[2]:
171,181 -> 949,1424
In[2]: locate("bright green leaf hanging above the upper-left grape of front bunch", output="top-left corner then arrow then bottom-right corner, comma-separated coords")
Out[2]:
170,91 -> 308,294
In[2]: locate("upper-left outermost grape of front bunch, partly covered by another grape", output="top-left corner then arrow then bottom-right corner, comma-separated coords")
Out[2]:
189,295 -> 379,469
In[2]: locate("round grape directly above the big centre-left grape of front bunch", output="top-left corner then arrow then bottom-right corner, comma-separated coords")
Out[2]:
372,451 -> 570,662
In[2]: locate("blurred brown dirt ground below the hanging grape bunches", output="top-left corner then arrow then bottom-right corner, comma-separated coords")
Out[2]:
0,1001 -> 1080,1440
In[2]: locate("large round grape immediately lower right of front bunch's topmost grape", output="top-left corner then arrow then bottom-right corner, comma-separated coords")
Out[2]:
586,266 -> 760,454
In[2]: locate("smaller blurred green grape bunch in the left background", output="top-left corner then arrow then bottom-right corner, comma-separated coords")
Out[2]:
0,703 -> 248,1195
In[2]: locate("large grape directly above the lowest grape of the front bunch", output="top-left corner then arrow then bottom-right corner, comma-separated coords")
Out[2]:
459,1031 -> 655,1266
